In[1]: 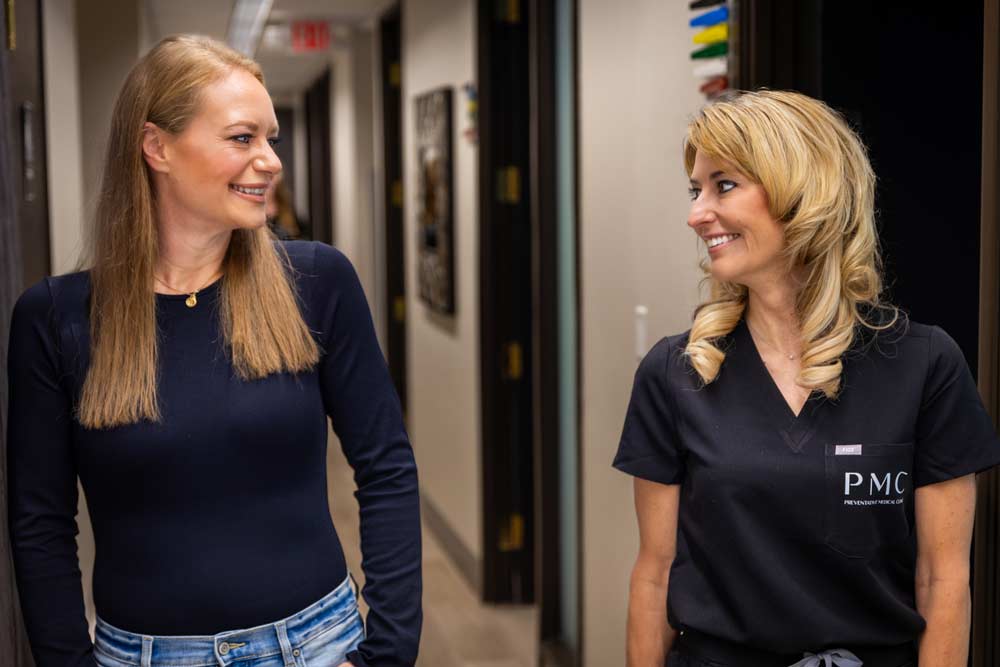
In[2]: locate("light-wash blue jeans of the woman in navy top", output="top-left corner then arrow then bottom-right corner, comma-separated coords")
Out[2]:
94,577 -> 365,667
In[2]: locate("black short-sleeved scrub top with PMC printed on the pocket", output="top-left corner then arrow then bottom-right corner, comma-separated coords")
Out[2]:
614,320 -> 1000,653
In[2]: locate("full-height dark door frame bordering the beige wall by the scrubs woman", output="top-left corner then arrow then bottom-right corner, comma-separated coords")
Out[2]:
529,0 -> 583,667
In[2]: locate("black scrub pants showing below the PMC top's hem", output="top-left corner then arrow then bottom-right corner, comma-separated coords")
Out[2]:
677,630 -> 917,667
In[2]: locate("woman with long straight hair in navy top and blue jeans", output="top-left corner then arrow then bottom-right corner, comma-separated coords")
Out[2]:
8,36 -> 421,667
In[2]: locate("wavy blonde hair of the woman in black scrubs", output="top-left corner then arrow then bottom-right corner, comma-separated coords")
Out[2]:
684,90 -> 899,399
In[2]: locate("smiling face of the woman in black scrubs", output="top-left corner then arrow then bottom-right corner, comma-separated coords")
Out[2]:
688,151 -> 785,288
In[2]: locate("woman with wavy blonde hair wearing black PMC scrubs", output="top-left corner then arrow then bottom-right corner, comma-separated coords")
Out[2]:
614,91 -> 1000,667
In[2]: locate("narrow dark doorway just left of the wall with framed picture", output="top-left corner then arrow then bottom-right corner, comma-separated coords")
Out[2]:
379,6 -> 407,417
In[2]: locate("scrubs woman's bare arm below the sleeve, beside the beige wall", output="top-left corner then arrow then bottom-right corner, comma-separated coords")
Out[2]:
625,477 -> 680,667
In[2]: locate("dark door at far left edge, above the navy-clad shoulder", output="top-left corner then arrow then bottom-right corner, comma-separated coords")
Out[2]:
3,0 -> 51,286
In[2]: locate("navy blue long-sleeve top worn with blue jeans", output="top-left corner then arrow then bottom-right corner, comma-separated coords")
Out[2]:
8,242 -> 421,667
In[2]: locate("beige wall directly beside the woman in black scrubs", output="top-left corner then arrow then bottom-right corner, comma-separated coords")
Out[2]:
579,0 -> 702,665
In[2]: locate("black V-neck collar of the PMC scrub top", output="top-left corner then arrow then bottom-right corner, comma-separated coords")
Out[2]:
726,316 -> 825,452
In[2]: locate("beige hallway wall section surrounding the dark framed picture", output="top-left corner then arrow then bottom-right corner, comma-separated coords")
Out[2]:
403,0 -> 482,558
